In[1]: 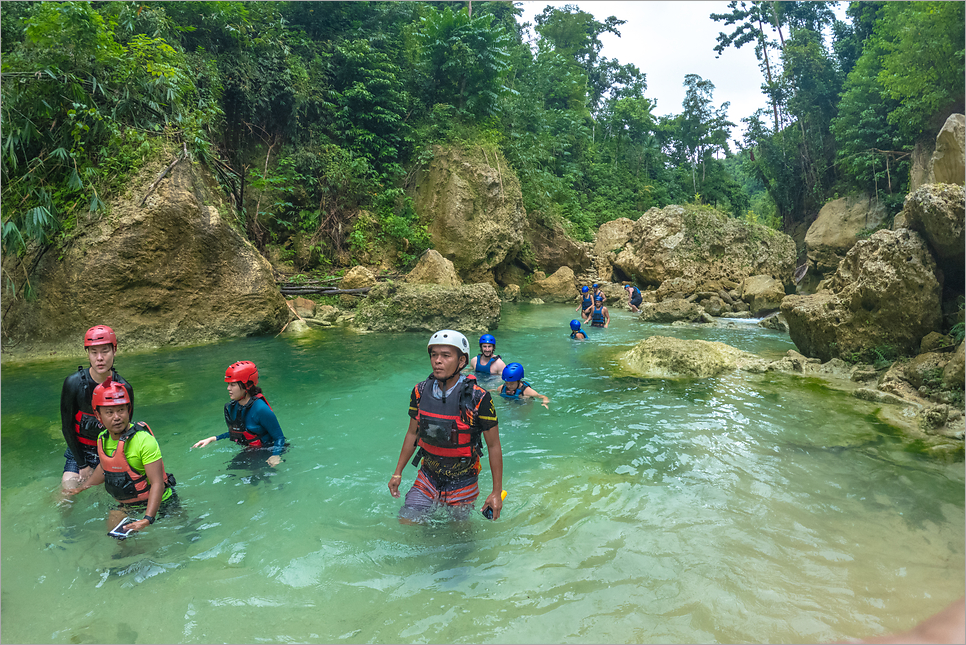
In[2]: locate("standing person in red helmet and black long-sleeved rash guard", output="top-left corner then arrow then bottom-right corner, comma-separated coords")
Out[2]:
60,325 -> 134,489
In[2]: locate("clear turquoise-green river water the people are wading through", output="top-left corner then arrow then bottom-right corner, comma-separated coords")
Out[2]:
0,305 -> 966,643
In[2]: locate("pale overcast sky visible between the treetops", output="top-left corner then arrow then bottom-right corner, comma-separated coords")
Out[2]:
520,0 -> 846,146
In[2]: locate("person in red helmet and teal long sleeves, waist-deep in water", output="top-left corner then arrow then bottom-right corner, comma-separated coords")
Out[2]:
192,361 -> 285,468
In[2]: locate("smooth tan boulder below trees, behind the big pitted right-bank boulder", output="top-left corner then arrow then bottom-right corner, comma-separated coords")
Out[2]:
805,194 -> 888,275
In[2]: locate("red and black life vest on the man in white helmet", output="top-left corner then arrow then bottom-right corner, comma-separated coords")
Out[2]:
416,376 -> 486,458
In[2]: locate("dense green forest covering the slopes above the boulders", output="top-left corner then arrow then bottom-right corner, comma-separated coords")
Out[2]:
0,0 -> 964,265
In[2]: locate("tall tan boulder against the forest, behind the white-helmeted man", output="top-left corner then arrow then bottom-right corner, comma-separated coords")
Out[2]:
414,146 -> 527,282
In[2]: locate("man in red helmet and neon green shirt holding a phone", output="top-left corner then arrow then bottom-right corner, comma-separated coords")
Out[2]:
69,379 -> 177,531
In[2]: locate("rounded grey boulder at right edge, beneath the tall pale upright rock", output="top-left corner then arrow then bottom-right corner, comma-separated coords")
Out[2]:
896,184 -> 966,288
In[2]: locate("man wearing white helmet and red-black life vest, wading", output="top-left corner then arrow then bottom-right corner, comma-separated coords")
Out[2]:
389,329 -> 503,522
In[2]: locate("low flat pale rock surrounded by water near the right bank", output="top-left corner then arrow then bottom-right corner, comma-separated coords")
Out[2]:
620,336 -> 757,378
